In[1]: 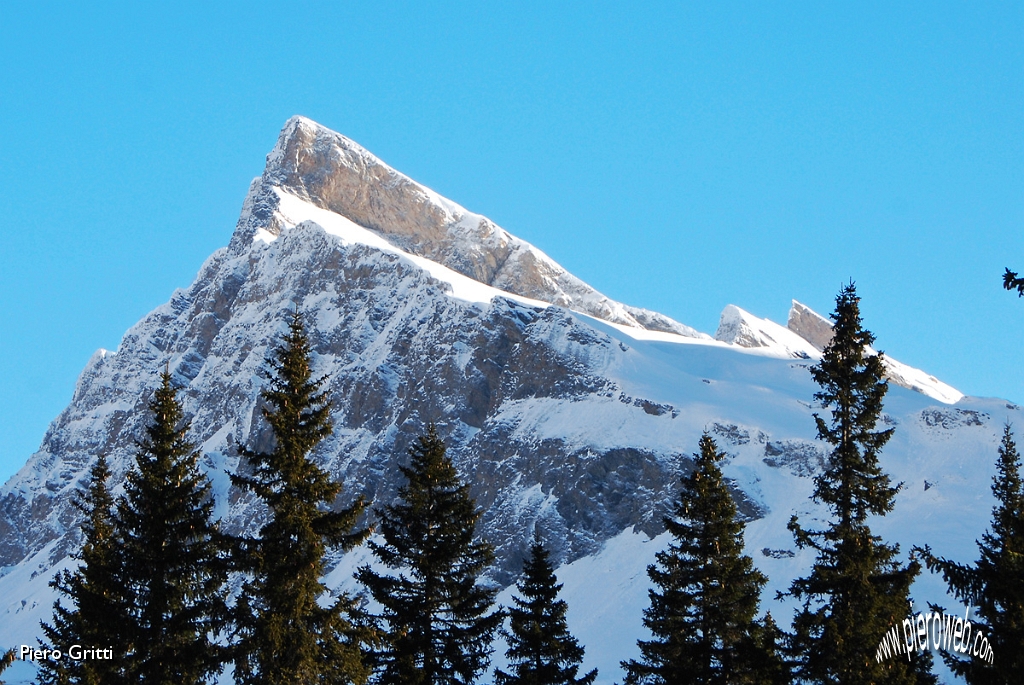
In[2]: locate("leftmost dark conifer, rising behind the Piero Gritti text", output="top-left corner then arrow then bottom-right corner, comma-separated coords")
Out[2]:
39,456 -> 127,685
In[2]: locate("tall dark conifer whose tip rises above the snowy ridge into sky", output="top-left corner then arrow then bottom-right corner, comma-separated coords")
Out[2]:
788,284 -> 920,685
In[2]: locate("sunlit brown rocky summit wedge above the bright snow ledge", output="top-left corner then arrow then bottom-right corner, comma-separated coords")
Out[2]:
230,117 -> 708,338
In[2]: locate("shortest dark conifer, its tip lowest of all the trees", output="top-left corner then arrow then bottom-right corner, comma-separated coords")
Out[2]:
495,542 -> 597,685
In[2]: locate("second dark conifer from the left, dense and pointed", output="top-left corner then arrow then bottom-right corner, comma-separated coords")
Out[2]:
114,372 -> 226,685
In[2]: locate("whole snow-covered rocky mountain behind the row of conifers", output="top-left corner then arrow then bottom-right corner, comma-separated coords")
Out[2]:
0,118 -> 1020,683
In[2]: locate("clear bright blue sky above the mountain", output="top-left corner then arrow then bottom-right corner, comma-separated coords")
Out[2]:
0,1 -> 1024,480
